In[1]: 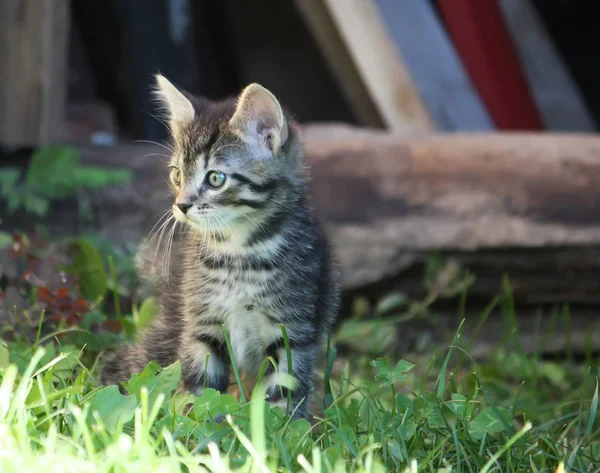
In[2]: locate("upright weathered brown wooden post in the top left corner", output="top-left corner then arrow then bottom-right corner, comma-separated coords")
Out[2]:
0,0 -> 69,147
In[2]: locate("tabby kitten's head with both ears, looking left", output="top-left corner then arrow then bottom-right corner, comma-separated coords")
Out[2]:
156,75 -> 302,242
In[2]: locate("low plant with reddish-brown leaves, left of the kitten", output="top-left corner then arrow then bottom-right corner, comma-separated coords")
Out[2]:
0,233 -> 129,358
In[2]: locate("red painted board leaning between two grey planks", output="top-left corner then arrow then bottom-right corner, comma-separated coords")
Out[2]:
437,0 -> 543,130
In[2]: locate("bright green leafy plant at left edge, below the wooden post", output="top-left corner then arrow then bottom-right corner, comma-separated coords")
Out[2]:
0,146 -> 131,217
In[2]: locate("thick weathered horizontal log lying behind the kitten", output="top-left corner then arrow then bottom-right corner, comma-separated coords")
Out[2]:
3,126 -> 600,306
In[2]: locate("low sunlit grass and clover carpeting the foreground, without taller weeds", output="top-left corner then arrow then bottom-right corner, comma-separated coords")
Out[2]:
0,312 -> 600,473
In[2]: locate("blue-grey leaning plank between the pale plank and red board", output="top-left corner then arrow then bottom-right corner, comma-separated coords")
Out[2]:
376,0 -> 495,131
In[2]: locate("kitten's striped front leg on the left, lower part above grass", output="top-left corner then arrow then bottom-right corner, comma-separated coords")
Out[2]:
180,330 -> 229,396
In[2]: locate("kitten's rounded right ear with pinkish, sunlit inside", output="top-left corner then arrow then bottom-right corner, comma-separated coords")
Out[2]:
229,84 -> 288,158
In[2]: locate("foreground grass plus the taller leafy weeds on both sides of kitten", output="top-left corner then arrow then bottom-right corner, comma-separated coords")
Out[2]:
0,236 -> 600,473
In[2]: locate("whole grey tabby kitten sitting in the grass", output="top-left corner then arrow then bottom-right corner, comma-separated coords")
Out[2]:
102,75 -> 340,417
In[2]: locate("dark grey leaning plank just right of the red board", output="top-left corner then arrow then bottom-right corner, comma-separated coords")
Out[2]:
499,0 -> 596,132
